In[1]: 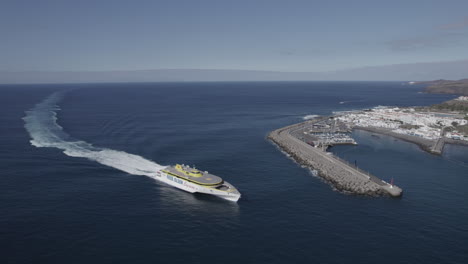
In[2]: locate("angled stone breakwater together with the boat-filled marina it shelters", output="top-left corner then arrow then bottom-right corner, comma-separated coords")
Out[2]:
268,117 -> 402,197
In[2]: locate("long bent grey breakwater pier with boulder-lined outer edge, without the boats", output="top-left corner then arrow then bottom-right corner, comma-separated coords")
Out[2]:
268,120 -> 402,197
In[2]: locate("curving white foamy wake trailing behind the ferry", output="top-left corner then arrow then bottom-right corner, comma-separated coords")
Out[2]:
23,92 -> 165,178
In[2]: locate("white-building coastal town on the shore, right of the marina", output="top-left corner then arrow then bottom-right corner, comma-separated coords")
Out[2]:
334,104 -> 468,155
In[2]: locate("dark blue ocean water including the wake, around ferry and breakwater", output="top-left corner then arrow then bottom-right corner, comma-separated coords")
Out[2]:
0,82 -> 468,263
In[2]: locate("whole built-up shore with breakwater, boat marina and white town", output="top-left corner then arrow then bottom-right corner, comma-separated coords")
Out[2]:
267,83 -> 468,197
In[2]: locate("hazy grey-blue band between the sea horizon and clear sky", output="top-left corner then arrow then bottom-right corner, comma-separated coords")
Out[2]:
0,59 -> 468,84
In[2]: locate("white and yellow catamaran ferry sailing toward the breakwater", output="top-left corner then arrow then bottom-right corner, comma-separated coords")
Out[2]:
156,164 -> 241,202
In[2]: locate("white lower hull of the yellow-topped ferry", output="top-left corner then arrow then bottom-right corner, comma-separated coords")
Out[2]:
156,171 -> 240,202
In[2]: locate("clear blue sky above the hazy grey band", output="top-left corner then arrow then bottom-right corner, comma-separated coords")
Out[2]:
0,0 -> 468,71
